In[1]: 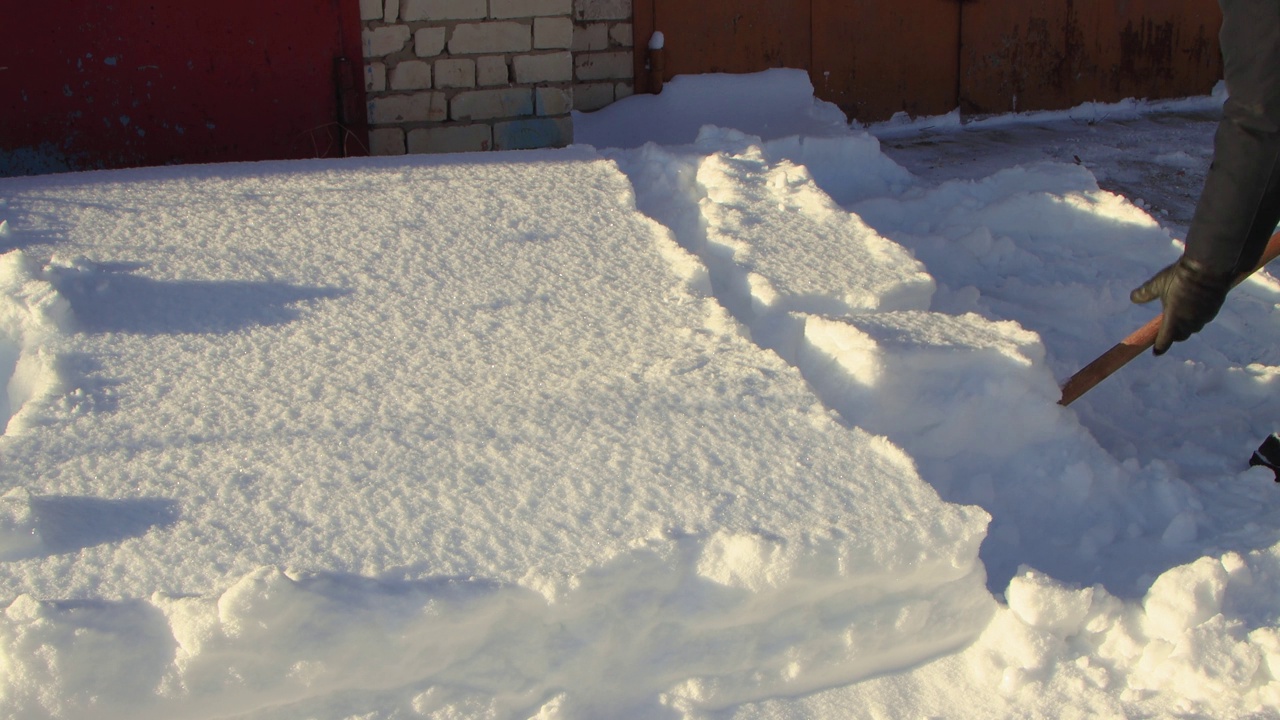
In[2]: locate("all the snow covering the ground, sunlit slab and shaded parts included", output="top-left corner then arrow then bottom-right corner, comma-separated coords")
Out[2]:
0,70 -> 1280,720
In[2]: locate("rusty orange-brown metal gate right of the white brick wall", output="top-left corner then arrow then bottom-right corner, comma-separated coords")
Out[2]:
634,0 -> 1221,122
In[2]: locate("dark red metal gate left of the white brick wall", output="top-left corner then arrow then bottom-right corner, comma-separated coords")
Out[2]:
0,0 -> 367,176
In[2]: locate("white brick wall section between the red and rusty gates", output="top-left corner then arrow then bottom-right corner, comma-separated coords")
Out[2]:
360,0 -> 632,155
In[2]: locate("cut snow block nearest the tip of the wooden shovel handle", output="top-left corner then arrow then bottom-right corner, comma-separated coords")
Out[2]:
801,311 -> 1061,460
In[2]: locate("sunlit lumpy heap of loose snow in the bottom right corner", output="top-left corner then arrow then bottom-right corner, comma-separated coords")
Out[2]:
733,547 -> 1280,720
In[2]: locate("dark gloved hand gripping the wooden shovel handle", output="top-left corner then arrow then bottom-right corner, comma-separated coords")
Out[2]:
1129,256 -> 1234,355
